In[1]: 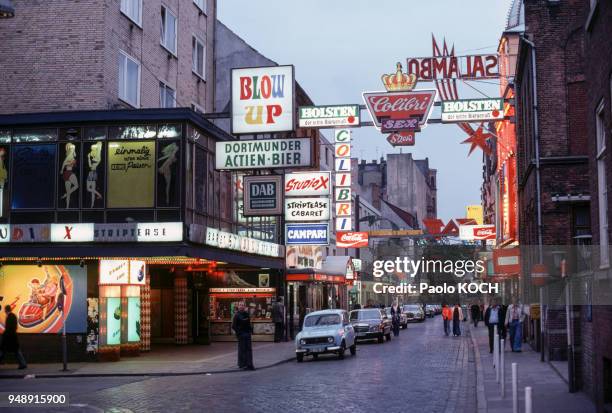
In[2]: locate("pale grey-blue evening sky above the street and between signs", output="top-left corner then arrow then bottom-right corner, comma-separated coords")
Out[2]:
218,0 -> 511,222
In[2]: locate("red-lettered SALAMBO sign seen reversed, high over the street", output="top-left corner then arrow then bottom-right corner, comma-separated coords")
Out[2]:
407,54 -> 499,81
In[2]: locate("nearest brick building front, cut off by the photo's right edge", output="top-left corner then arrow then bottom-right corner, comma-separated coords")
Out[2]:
582,0 -> 612,411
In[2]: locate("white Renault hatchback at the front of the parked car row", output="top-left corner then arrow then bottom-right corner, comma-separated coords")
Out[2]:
295,310 -> 357,363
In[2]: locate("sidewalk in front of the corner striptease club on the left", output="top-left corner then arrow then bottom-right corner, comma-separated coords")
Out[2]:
0,341 -> 295,379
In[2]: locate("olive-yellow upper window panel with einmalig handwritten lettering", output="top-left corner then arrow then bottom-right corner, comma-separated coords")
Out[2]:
107,141 -> 156,208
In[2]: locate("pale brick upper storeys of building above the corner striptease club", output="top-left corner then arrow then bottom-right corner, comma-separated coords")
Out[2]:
0,0 -> 216,114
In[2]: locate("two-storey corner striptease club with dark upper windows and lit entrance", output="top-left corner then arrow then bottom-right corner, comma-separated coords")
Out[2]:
0,109 -> 285,362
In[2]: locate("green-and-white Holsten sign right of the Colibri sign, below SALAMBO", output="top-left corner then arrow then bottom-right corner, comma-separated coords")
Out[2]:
441,99 -> 504,123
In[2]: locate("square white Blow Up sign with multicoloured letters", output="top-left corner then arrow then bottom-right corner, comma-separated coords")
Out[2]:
232,66 -> 295,134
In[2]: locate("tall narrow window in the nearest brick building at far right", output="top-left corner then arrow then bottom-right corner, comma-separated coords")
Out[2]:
595,100 -> 610,267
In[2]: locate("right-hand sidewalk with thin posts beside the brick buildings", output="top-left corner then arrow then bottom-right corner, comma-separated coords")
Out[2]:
470,324 -> 595,413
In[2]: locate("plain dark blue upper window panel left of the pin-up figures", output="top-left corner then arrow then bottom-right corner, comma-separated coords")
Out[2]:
11,143 -> 57,209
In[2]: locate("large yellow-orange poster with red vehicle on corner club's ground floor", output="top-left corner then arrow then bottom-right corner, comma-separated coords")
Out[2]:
0,265 -> 87,333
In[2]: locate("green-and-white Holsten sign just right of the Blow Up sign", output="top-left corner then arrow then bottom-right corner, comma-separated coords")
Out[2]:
299,105 -> 360,128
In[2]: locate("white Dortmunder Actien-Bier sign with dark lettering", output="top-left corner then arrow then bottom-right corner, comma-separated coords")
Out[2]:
215,138 -> 312,170
